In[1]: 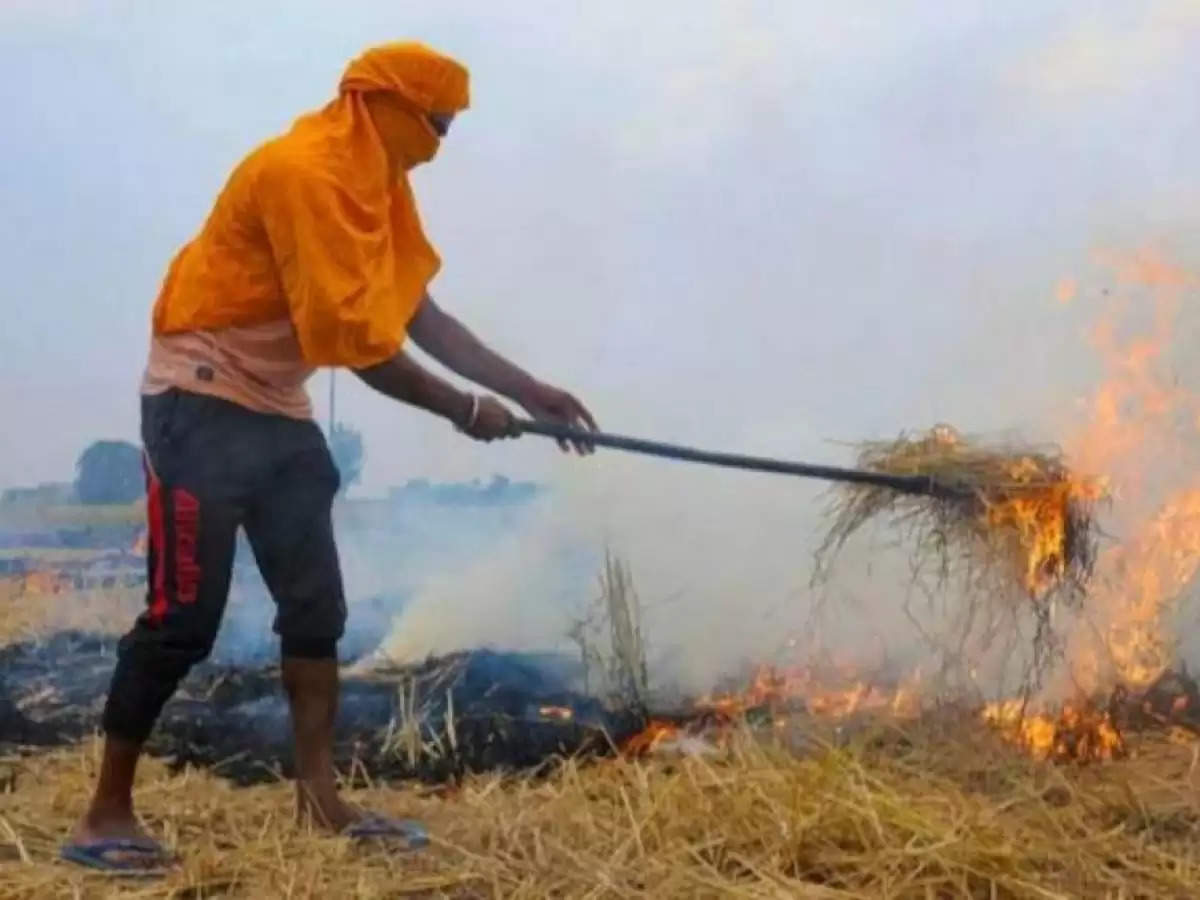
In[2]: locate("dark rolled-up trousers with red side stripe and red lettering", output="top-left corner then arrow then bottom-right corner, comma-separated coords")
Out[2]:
104,390 -> 346,738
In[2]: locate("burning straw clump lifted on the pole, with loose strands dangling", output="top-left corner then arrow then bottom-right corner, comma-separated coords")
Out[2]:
814,425 -> 1104,689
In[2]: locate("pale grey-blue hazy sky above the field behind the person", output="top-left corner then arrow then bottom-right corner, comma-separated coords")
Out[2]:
0,0 -> 1200,488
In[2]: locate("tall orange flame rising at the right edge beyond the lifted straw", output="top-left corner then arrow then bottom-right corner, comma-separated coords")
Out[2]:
1057,251 -> 1200,692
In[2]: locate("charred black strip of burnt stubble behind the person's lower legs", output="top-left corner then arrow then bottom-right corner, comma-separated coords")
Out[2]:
0,631 -> 644,784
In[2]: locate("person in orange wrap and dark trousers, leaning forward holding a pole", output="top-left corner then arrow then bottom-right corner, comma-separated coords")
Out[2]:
62,43 -> 595,869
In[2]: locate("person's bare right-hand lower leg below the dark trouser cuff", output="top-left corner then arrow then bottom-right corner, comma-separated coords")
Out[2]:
283,656 -> 362,832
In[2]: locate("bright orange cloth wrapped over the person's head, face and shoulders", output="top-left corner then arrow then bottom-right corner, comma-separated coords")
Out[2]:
155,42 -> 469,367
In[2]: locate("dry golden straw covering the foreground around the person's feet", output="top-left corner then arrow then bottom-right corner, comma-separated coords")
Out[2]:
0,726 -> 1200,900
